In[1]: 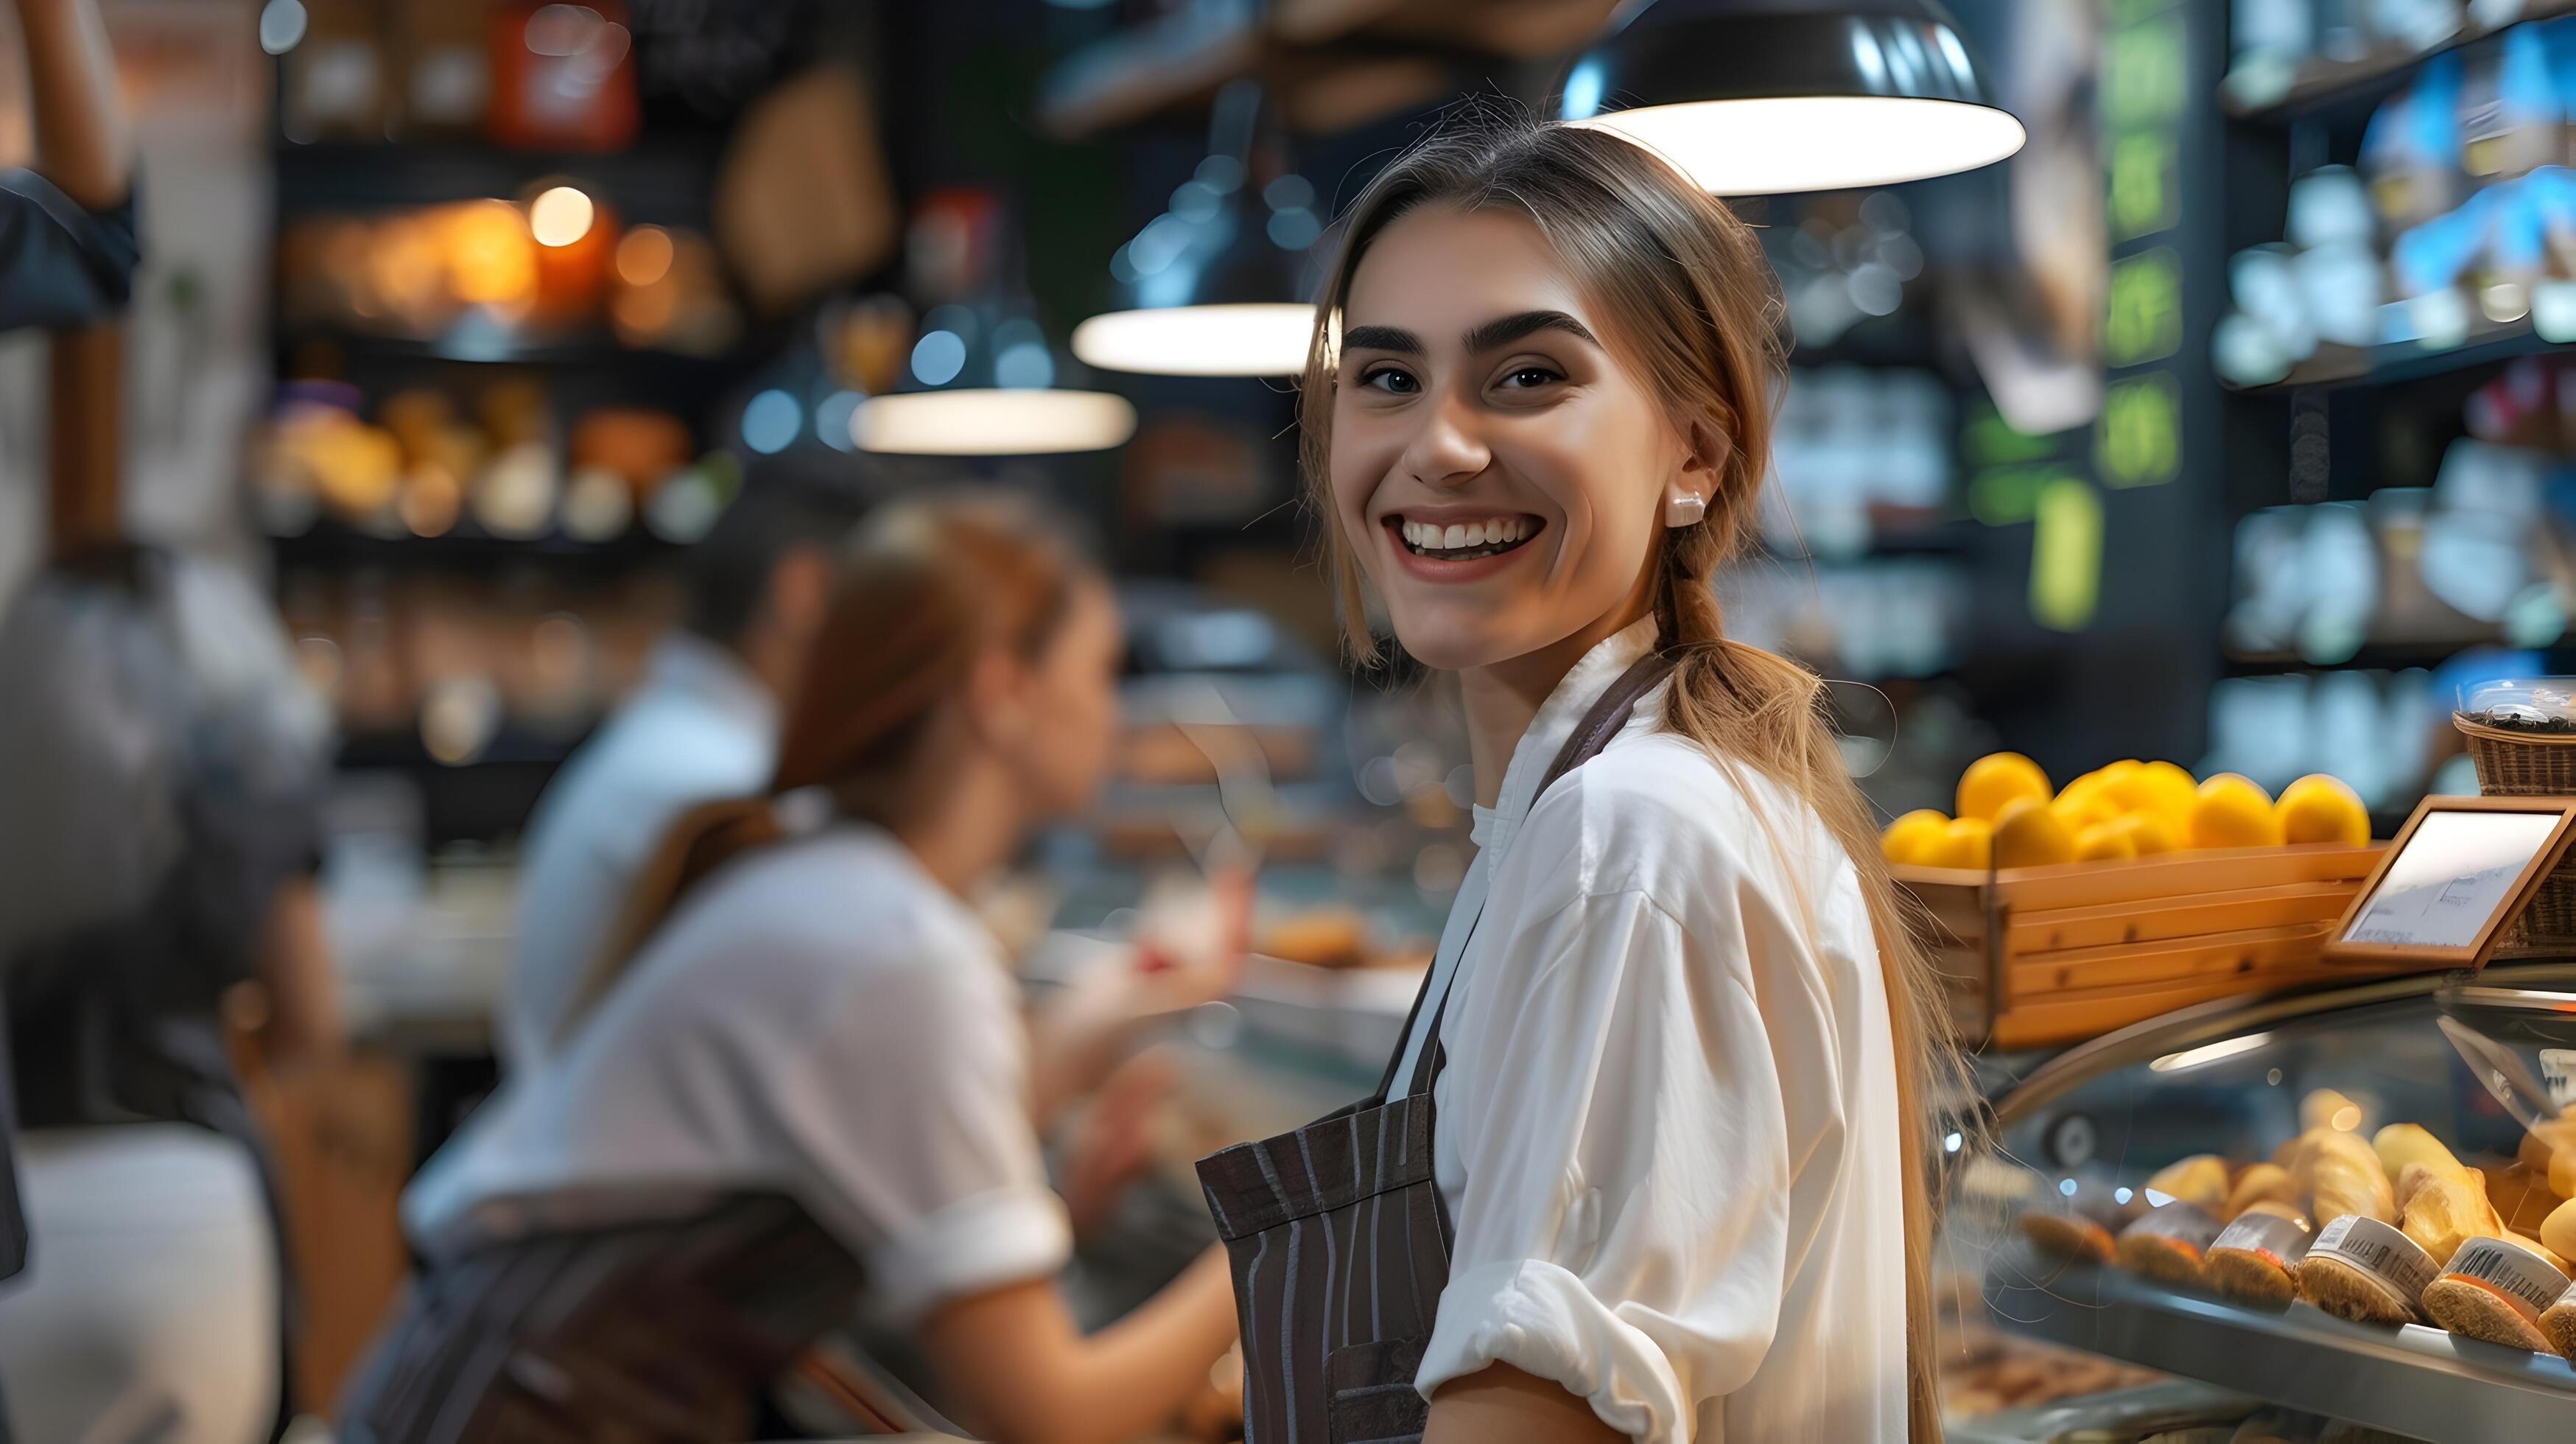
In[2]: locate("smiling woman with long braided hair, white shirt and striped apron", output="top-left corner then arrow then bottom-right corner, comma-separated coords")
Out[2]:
1201,119 -> 1958,1444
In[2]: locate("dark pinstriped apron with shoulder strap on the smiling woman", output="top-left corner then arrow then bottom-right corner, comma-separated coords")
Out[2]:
1198,655 -> 1672,1444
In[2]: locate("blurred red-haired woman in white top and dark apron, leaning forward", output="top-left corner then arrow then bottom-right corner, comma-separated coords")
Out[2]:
340,503 -> 1234,1444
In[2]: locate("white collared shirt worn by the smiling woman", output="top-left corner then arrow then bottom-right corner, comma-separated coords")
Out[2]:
1414,622 -> 1906,1444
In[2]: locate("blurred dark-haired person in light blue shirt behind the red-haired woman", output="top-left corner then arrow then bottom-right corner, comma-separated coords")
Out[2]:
492,472 -> 858,1068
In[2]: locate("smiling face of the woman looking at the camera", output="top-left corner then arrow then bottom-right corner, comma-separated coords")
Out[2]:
1332,204 -> 1708,668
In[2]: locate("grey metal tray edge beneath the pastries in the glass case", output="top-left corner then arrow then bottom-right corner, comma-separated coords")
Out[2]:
1986,1241 -> 2576,1444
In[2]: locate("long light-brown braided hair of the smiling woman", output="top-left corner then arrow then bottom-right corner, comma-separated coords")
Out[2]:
1298,116 -> 1965,1442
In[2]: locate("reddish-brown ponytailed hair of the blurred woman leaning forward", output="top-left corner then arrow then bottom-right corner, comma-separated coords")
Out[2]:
561,498 -> 1089,1037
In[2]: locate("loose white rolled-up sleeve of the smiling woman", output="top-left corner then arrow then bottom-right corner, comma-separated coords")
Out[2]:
1414,887 -> 1795,1442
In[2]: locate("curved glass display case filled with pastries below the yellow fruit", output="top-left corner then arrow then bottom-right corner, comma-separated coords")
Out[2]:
1945,962 -> 2576,1444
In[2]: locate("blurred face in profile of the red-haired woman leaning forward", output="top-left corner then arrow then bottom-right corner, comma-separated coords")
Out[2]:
1002,578 -> 1126,820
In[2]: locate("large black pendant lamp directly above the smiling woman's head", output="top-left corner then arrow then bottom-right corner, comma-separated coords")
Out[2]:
1556,0 -> 2025,196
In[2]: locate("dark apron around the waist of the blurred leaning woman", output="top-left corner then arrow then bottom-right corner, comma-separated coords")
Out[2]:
337,1194 -> 863,1444
